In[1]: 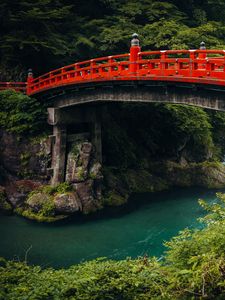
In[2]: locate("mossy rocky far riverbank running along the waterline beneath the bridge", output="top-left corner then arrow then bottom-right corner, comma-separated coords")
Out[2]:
0,161 -> 225,222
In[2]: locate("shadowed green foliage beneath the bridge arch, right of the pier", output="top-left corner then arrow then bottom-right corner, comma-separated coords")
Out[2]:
102,103 -> 222,168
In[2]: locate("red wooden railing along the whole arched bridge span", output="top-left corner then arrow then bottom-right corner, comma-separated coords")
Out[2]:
27,50 -> 225,95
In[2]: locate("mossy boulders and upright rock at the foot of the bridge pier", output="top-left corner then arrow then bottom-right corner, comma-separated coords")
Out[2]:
10,141 -> 102,222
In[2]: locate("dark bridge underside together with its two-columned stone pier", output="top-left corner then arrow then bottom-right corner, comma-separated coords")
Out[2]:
43,81 -> 225,185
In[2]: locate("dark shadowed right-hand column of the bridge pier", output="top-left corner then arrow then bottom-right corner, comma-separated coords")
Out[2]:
91,109 -> 102,163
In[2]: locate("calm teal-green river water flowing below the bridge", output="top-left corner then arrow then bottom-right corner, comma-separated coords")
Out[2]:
0,189 -> 221,268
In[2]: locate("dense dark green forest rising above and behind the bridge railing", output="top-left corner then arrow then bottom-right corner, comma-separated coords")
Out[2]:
0,0 -> 225,81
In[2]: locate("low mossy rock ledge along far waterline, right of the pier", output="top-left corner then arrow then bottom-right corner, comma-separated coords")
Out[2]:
103,161 -> 225,206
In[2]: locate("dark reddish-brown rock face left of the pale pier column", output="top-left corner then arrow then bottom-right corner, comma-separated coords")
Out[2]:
0,130 -> 51,182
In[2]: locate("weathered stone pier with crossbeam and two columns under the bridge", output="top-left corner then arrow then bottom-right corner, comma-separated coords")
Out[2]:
48,107 -> 102,185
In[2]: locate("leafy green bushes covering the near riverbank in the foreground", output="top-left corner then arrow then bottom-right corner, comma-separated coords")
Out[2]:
0,191 -> 225,300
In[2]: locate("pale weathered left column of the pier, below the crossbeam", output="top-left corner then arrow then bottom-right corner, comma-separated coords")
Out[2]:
51,125 -> 67,185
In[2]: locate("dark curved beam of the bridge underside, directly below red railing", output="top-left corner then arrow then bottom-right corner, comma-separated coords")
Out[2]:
42,81 -> 225,111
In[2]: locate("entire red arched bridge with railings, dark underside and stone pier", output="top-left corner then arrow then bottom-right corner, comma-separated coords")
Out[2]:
0,34 -> 225,184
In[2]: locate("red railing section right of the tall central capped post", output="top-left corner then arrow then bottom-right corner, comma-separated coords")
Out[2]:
137,50 -> 225,80
